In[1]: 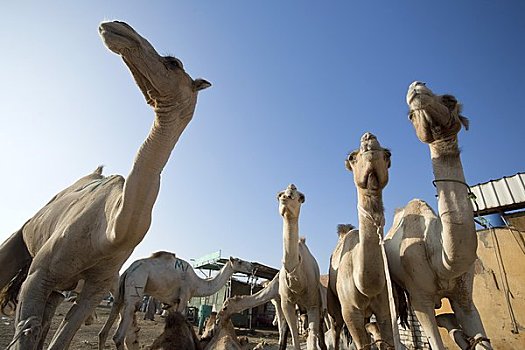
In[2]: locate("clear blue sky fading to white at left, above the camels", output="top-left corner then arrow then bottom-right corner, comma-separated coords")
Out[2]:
0,0 -> 525,273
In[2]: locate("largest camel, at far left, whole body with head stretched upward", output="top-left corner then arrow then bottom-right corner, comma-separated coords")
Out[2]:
0,21 -> 211,350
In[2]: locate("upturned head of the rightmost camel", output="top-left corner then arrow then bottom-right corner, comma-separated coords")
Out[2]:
406,81 -> 469,143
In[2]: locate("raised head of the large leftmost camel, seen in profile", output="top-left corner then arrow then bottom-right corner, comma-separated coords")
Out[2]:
99,21 -> 211,111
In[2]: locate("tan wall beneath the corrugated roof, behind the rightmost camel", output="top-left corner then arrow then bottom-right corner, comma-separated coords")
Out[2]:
437,213 -> 525,350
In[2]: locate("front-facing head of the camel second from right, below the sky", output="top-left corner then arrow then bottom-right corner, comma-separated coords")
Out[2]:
345,132 -> 391,191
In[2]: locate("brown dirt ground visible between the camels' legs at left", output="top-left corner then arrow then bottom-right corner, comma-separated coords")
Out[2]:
0,302 -> 286,350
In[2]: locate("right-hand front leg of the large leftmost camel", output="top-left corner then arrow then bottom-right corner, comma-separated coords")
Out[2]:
48,281 -> 106,350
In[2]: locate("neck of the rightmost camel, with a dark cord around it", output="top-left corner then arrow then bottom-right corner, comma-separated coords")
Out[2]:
430,137 -> 477,278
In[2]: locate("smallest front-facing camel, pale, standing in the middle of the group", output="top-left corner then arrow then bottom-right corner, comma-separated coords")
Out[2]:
277,184 -> 326,350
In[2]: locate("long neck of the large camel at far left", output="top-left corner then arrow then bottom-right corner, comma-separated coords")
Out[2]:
110,99 -> 196,249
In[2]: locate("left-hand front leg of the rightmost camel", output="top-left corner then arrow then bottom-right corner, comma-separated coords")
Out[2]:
410,296 -> 445,350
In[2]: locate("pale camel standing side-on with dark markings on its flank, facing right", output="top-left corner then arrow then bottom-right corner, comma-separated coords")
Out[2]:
98,251 -> 253,350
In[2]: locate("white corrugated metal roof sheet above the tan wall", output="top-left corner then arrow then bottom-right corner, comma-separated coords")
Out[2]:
470,173 -> 525,215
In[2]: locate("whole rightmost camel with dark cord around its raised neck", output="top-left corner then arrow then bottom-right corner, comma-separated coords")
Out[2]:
385,81 -> 491,350
